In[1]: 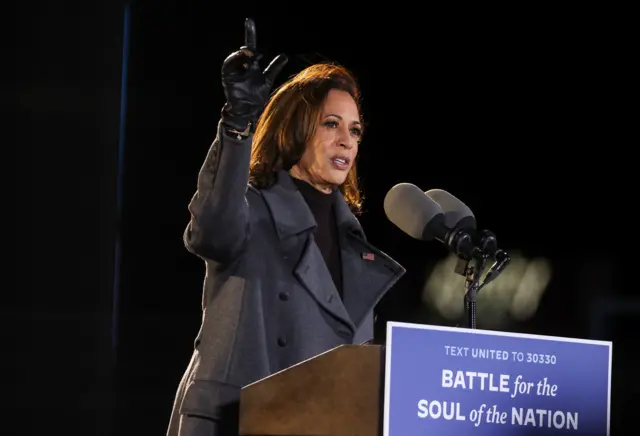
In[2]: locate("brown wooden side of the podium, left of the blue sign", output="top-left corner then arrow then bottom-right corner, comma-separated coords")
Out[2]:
239,345 -> 385,436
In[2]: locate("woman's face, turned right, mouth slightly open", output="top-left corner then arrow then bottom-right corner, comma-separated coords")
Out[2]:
291,89 -> 362,193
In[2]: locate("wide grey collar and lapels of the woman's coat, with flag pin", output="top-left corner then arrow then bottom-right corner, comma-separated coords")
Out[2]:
261,171 -> 405,331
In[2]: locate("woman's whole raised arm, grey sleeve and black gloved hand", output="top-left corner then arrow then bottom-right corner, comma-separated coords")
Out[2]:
184,19 -> 287,262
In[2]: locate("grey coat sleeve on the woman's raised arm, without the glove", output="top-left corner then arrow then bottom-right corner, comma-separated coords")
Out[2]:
184,119 -> 253,263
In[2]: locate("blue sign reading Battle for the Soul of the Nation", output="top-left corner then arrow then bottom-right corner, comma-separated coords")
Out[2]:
384,322 -> 612,436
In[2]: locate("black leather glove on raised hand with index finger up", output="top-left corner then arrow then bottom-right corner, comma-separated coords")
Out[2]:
222,18 -> 288,135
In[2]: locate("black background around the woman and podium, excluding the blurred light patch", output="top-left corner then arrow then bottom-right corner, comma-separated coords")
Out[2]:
17,0 -> 640,435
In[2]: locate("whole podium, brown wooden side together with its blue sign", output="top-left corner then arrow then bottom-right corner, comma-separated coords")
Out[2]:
238,322 -> 612,436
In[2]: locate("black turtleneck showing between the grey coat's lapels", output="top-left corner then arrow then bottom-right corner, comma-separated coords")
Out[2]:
292,177 -> 342,297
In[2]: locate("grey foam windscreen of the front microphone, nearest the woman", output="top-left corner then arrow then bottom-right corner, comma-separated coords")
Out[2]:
384,183 -> 442,240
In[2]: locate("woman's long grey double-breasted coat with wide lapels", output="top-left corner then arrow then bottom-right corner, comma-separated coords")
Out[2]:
167,120 -> 405,436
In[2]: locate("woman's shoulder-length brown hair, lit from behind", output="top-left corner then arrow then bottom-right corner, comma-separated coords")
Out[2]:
249,63 -> 364,214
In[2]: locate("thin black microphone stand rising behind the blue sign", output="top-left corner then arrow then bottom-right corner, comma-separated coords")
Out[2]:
455,230 -> 511,329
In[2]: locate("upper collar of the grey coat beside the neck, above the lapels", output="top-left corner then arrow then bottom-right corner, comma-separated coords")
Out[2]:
262,170 -> 363,239
